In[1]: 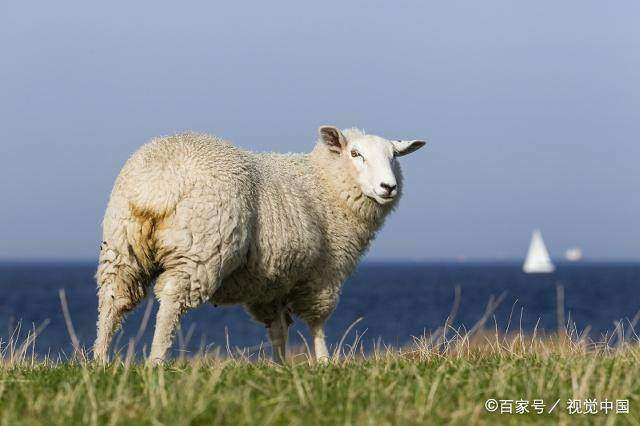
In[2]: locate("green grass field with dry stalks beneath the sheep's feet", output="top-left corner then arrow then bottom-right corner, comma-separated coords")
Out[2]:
0,334 -> 640,425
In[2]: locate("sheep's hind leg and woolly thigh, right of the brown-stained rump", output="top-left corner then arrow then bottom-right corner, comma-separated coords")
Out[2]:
149,191 -> 249,364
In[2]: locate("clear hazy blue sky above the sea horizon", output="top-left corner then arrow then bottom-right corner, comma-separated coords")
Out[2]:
0,0 -> 640,260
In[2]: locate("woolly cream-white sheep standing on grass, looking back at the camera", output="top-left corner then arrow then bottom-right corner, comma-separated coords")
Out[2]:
94,126 -> 425,363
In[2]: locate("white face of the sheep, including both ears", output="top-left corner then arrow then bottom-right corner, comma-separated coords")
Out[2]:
319,126 -> 425,205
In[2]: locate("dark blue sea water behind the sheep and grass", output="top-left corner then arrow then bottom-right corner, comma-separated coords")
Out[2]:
0,263 -> 640,355
